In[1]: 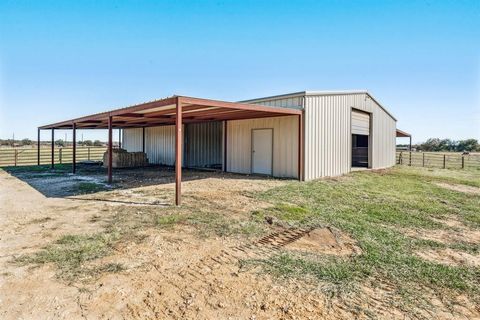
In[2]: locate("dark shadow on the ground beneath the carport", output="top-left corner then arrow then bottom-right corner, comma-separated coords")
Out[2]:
2,163 -> 278,205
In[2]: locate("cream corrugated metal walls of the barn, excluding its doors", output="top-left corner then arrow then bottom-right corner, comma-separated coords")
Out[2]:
123,93 -> 396,180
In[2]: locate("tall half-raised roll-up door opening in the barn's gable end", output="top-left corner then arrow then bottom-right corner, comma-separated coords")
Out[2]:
352,110 -> 370,168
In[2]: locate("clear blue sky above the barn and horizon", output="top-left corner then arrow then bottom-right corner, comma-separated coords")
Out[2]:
0,0 -> 480,141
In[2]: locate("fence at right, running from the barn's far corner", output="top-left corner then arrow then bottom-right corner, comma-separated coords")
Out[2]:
397,151 -> 480,169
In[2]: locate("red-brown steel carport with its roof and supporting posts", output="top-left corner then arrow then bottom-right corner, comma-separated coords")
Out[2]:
38,96 -> 303,205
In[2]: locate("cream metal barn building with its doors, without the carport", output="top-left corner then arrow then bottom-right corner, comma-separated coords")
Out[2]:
123,91 -> 396,180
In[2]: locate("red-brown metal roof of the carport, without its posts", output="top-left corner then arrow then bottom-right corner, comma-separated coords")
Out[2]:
39,96 -> 302,129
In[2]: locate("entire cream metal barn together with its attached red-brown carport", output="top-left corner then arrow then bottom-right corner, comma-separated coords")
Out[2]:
38,91 -> 397,204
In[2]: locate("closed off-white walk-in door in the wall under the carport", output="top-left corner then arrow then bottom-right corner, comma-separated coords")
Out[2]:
252,129 -> 273,175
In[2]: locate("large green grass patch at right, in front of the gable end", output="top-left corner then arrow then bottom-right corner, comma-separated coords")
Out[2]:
255,167 -> 480,301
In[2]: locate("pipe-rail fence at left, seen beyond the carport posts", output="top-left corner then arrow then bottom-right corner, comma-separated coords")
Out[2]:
0,147 -> 107,167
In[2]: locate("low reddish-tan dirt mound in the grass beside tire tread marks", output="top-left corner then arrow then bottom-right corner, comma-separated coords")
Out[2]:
285,228 -> 360,256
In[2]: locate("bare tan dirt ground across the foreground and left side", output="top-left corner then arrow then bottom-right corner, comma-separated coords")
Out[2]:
0,166 -> 478,319
